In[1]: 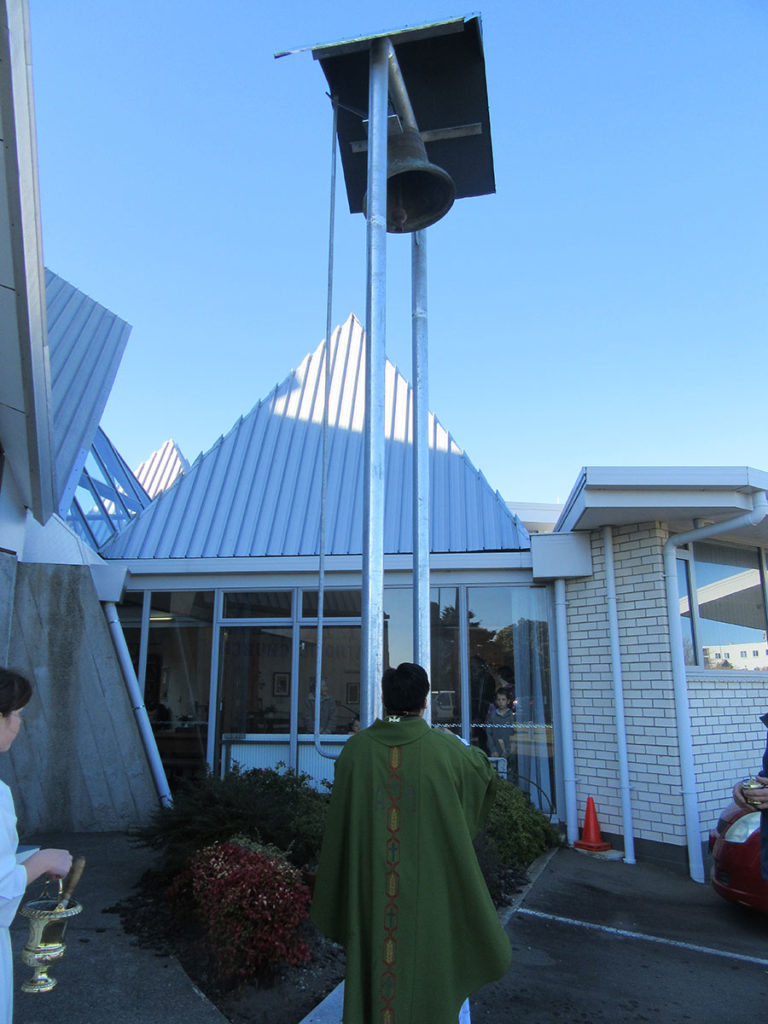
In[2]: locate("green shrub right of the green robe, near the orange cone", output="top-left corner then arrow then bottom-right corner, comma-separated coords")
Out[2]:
482,779 -> 561,869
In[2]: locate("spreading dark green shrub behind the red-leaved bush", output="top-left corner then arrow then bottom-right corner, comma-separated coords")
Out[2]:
134,765 -> 329,873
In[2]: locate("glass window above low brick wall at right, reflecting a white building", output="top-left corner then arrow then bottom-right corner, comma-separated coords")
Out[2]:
693,543 -> 768,670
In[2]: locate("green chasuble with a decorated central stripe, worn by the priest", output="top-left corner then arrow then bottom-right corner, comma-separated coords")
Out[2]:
311,718 -> 511,1024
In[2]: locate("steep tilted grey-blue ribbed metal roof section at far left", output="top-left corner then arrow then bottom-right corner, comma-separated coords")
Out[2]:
45,268 -> 131,516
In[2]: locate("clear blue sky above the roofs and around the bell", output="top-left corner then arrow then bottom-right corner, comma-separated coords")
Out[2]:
30,0 -> 768,502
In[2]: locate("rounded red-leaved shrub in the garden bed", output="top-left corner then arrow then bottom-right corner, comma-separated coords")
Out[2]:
188,843 -> 310,984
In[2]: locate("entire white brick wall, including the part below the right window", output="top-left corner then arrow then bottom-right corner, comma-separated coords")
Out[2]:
566,523 -> 768,846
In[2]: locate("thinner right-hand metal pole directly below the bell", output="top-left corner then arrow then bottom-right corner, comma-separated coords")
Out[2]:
411,231 -> 432,722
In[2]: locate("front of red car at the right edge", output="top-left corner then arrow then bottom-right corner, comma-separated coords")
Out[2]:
710,803 -> 768,913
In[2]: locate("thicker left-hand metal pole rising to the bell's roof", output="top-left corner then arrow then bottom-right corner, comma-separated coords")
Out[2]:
360,39 -> 389,727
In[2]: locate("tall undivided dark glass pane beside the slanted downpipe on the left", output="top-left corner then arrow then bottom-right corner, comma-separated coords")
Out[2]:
145,591 -> 214,785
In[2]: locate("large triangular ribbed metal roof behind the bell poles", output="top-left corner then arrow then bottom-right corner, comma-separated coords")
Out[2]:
101,316 -> 528,559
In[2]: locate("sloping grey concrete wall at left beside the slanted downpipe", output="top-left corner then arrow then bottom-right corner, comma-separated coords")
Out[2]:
0,555 -> 158,836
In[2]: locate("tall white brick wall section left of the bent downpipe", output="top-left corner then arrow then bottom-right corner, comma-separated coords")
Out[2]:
567,523 -> 685,847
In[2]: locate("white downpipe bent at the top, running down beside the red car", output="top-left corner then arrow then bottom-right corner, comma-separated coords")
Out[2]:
664,490 -> 768,883
